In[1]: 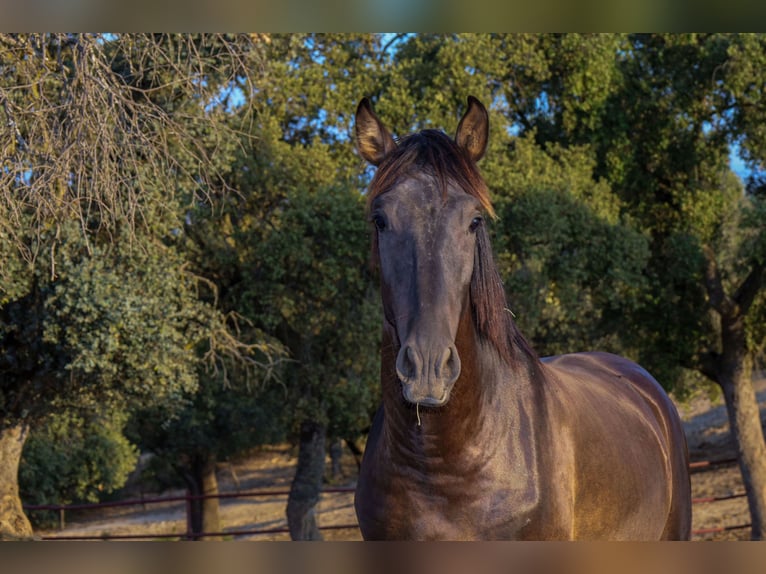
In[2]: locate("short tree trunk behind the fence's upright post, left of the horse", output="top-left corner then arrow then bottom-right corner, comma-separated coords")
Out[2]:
183,456 -> 222,541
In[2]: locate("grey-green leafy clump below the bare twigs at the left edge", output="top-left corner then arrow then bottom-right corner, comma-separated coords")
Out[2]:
0,223 -> 220,424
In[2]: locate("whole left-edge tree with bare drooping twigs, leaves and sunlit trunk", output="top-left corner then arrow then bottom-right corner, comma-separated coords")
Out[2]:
0,34 -> 274,536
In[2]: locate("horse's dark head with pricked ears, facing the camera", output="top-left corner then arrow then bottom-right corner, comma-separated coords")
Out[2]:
356,97 -> 493,406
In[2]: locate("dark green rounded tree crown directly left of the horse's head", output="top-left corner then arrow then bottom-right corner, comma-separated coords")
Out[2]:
242,186 -> 380,433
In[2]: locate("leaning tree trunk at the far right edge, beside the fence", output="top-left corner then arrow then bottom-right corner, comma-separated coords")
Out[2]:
719,355 -> 766,540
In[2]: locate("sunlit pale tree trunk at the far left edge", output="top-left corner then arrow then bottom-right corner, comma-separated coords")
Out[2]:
0,425 -> 33,540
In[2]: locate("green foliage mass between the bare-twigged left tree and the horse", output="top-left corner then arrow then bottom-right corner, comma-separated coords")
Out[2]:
131,34 -> 388,480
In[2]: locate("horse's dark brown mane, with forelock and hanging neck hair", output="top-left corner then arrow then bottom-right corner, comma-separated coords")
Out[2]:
367,130 -> 534,364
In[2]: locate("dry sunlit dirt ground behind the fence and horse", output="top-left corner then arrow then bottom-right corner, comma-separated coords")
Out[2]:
37,379 -> 766,541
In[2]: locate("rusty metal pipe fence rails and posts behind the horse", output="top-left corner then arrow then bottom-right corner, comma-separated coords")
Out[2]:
24,458 -> 752,540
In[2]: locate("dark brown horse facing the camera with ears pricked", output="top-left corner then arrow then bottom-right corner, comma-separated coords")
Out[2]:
355,97 -> 691,540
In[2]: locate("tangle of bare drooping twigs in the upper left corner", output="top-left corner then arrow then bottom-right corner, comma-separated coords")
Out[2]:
0,34 -> 265,268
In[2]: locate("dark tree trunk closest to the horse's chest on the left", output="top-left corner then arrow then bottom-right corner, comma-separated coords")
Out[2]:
287,421 -> 326,540
